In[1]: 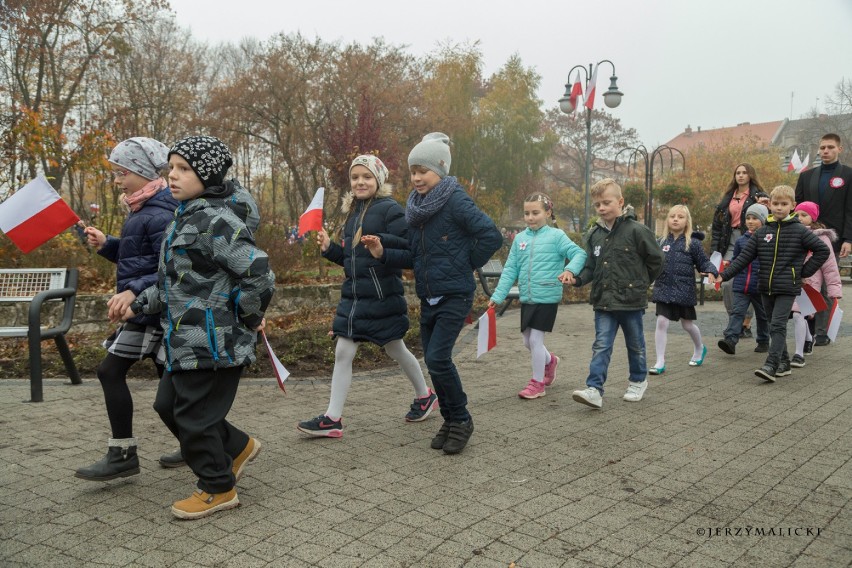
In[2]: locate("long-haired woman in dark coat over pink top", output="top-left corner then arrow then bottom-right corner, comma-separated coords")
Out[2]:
710,162 -> 763,332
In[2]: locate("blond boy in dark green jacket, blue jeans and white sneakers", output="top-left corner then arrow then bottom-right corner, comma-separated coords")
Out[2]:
572,178 -> 665,408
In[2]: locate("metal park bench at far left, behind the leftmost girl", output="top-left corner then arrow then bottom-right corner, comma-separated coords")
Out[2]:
0,268 -> 82,402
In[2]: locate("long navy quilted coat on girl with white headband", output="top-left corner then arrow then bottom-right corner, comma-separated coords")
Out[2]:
323,192 -> 409,345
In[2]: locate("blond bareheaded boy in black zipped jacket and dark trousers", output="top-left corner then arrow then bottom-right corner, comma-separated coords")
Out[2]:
719,185 -> 829,383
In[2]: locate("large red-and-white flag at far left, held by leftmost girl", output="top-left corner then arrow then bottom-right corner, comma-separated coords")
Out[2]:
0,176 -> 80,253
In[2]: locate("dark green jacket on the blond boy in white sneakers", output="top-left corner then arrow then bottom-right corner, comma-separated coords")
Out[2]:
576,205 -> 665,311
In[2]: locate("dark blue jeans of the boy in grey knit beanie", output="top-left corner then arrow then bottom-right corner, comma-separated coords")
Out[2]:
420,293 -> 473,422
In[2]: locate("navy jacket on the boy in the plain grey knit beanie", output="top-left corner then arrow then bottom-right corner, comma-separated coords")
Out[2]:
382,180 -> 503,300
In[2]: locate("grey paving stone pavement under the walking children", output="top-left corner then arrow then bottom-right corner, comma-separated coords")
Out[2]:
0,296 -> 852,568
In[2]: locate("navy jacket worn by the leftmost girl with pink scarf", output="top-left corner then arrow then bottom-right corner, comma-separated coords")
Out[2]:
98,188 -> 178,325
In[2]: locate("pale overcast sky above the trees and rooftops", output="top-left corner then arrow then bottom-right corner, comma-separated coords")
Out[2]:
170,0 -> 852,148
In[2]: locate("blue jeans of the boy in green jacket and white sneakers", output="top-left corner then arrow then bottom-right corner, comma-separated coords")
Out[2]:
586,310 -> 648,395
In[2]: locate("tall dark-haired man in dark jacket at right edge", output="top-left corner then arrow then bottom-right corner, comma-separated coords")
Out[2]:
796,133 -> 852,346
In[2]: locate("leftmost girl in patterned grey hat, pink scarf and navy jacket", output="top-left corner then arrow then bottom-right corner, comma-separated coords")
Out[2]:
74,137 -> 182,481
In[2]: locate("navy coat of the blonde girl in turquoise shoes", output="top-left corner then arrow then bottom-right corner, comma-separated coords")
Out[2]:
651,231 -> 718,306
